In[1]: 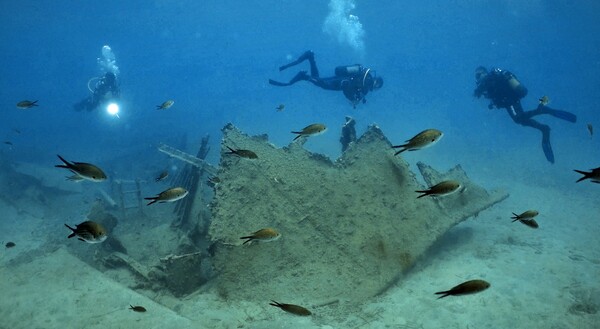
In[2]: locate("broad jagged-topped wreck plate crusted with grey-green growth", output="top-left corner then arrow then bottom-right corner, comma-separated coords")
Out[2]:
209,125 -> 507,304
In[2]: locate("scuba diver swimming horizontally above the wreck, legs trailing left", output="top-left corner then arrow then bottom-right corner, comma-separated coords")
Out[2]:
269,50 -> 383,108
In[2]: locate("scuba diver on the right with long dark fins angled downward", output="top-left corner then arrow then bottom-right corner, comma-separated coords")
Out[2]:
474,66 -> 577,163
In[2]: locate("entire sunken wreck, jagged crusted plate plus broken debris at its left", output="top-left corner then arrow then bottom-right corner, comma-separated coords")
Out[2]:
5,119 -> 508,307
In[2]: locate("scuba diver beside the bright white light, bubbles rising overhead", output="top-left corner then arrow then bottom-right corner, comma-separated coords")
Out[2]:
75,46 -> 120,111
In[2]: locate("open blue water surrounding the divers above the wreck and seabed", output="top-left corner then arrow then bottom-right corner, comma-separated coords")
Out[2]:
0,0 -> 600,326
